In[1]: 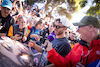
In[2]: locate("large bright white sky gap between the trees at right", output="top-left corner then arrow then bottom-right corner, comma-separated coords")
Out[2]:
70,0 -> 93,32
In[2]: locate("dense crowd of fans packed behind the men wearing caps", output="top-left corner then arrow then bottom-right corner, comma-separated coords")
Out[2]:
0,0 -> 78,45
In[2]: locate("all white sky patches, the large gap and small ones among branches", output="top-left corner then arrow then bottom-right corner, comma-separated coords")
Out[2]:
27,0 -> 93,31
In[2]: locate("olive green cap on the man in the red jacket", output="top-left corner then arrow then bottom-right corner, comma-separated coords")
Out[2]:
73,16 -> 100,29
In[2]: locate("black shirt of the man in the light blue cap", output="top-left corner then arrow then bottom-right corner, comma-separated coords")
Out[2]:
0,11 -> 15,34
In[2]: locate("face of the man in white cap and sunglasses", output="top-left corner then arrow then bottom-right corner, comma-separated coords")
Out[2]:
54,22 -> 65,35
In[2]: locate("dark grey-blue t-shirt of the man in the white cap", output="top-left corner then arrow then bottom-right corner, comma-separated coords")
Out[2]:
39,37 -> 71,67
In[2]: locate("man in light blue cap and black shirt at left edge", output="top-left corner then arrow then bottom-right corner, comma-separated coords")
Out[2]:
0,0 -> 15,37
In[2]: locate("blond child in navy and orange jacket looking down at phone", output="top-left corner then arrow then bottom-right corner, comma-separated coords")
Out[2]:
8,16 -> 30,42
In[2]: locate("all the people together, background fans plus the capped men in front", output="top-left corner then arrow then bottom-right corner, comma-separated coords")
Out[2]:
0,0 -> 100,67
